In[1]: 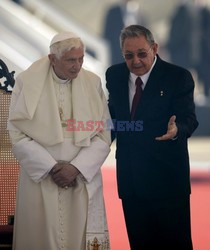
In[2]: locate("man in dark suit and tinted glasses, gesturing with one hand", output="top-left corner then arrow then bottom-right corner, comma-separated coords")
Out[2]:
106,25 -> 198,250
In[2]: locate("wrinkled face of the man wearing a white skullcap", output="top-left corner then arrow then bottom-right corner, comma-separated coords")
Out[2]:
49,48 -> 84,80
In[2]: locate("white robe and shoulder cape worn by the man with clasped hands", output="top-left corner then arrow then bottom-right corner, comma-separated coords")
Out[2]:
8,58 -> 110,250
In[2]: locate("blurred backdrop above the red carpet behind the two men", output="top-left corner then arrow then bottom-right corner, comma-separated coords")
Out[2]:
0,0 -> 210,250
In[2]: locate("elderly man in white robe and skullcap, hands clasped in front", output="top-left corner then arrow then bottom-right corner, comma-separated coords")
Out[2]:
8,32 -> 111,250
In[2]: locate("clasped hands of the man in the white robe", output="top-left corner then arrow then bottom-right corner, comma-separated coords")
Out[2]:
50,161 -> 79,188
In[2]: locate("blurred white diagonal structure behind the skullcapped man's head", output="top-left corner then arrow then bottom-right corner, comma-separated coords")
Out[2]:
0,0 -> 109,81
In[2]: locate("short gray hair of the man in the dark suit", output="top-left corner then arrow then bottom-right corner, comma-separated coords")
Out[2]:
120,24 -> 155,49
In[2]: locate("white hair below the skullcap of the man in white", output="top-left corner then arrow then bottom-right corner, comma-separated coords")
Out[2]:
50,37 -> 85,59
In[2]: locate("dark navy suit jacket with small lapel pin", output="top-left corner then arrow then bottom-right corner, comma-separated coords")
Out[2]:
106,55 -> 198,199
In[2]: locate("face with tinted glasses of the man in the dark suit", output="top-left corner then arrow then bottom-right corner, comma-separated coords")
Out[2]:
122,36 -> 158,76
